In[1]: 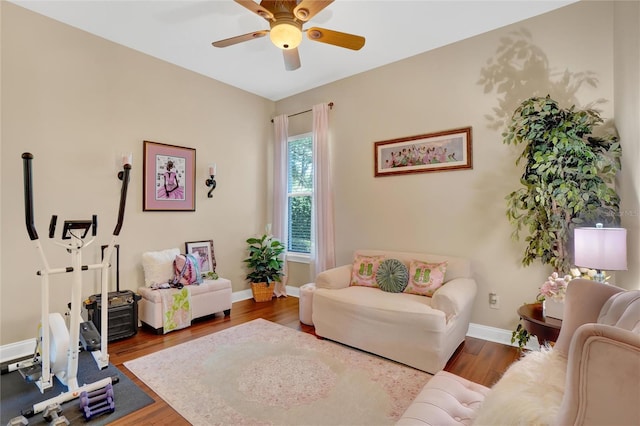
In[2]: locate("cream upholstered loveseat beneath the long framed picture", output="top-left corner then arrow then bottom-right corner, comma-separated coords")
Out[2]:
312,250 -> 477,373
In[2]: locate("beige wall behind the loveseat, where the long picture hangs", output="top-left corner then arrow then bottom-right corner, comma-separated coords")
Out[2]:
276,2 -> 639,329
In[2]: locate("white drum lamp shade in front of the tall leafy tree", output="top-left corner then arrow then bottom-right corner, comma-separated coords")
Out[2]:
574,227 -> 627,271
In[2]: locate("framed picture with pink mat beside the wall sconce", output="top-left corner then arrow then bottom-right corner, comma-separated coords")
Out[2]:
142,141 -> 196,211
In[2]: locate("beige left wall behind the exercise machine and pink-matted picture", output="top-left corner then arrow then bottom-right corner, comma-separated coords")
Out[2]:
0,2 -> 274,344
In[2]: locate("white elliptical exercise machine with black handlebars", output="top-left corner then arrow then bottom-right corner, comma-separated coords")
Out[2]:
14,152 -> 131,417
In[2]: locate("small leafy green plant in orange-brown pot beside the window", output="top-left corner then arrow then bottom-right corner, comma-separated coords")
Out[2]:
244,234 -> 285,302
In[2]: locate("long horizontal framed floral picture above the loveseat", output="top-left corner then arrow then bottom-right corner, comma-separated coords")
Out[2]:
374,127 -> 473,177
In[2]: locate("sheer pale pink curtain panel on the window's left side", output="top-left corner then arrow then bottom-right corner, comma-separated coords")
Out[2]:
271,115 -> 289,297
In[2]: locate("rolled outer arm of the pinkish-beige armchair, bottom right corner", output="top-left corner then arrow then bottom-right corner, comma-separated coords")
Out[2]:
556,324 -> 640,425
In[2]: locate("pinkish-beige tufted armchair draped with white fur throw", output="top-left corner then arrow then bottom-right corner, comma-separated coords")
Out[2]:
398,280 -> 640,425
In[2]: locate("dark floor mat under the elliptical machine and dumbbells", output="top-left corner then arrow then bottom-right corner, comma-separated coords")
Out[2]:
0,352 -> 154,426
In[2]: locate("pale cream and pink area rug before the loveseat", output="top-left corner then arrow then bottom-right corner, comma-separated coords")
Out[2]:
125,319 -> 431,426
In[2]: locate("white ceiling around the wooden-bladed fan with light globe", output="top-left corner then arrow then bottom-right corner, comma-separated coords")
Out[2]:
12,0 -> 577,101
